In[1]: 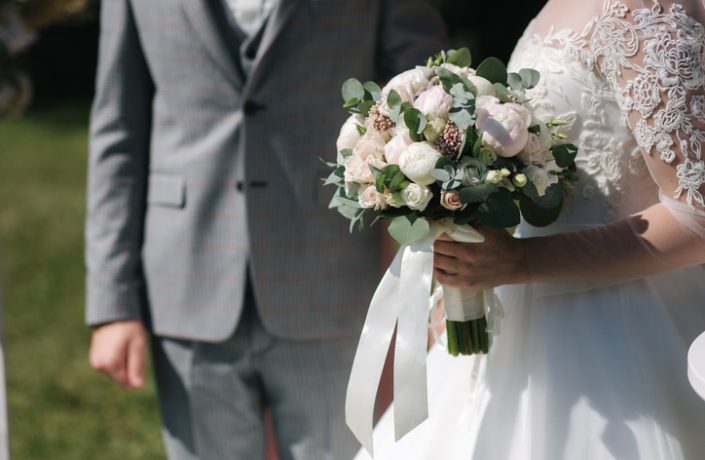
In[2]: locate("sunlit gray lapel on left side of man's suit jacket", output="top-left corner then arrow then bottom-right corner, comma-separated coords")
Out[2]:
178,0 -> 244,88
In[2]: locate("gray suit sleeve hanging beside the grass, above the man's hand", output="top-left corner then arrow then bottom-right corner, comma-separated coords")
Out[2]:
86,0 -> 154,325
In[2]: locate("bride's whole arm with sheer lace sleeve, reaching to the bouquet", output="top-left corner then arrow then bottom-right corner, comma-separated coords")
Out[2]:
435,1 -> 705,288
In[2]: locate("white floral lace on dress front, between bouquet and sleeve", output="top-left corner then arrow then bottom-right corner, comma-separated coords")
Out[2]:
510,12 -> 647,217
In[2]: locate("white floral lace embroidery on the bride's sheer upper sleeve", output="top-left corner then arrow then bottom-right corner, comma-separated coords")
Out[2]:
590,0 -> 705,207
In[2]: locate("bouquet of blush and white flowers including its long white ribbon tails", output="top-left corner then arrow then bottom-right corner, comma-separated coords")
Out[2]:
332,49 -> 577,453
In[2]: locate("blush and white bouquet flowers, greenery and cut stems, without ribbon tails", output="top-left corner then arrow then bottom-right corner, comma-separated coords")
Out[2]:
326,49 -> 577,355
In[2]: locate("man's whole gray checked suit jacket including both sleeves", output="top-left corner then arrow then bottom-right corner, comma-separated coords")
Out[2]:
86,0 -> 444,341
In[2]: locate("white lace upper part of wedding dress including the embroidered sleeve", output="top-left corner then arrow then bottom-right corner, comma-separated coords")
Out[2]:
509,0 -> 705,226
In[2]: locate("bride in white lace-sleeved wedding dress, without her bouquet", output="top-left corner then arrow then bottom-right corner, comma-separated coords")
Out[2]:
357,0 -> 705,460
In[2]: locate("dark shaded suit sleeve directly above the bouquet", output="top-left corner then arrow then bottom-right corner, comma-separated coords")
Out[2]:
378,0 -> 448,80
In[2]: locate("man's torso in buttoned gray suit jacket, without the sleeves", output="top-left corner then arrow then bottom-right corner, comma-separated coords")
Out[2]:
131,0 -> 388,340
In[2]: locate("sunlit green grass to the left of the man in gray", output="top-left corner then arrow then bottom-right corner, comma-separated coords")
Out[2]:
0,105 -> 164,460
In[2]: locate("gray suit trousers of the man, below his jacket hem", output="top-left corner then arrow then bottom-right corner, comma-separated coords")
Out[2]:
152,289 -> 359,460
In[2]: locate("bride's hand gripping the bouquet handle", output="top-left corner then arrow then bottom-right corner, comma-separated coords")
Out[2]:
433,227 -> 529,289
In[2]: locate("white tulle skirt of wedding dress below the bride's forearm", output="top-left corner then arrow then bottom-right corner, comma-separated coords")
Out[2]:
355,267 -> 705,460
